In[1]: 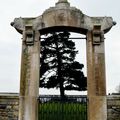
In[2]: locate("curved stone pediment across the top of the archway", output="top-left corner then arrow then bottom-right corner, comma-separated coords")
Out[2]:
11,0 -> 116,34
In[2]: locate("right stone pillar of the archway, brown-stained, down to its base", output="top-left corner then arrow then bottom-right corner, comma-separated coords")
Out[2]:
87,25 -> 107,120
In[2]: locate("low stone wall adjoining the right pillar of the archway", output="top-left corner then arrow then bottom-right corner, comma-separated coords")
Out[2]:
107,95 -> 120,120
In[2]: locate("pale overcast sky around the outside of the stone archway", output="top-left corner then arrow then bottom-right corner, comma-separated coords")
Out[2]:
0,0 -> 120,93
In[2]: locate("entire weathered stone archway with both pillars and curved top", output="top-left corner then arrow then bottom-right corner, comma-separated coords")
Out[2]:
11,0 -> 115,120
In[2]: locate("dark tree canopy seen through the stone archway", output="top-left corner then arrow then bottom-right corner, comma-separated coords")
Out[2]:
40,32 -> 87,97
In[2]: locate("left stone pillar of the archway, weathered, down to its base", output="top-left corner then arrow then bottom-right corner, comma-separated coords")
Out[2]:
19,26 -> 40,120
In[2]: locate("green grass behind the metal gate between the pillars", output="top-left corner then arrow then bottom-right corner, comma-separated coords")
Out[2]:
39,102 -> 87,120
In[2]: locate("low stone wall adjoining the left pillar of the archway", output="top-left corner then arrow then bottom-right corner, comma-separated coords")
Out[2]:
0,93 -> 19,120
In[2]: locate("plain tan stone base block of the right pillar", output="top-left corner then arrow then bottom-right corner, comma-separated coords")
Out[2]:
88,96 -> 107,120
